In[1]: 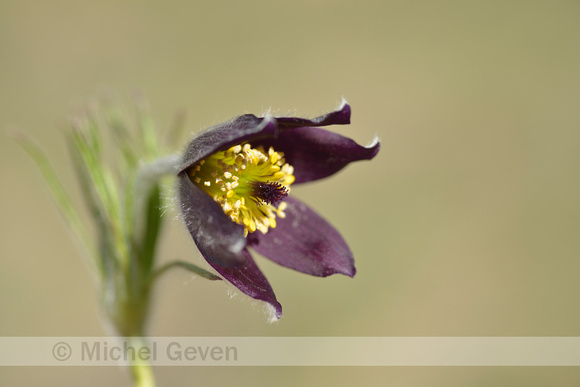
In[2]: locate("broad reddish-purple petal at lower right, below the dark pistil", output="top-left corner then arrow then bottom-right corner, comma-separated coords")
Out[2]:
248,197 -> 356,277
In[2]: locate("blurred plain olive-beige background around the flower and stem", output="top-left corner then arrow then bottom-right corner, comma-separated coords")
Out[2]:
0,0 -> 580,386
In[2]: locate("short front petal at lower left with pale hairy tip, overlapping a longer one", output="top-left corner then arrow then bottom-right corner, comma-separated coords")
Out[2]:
178,173 -> 246,267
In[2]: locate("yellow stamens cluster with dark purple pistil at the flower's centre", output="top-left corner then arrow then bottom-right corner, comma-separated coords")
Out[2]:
188,144 -> 294,236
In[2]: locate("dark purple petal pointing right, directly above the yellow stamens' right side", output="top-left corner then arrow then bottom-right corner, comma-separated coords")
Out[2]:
252,127 -> 380,183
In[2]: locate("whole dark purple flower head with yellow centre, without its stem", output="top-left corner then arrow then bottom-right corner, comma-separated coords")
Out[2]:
178,102 -> 380,318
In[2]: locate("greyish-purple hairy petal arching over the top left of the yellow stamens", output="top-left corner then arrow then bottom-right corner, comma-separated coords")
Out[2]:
179,114 -> 278,173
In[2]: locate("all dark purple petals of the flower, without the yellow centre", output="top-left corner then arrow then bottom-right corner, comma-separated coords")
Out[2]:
178,102 -> 380,318
